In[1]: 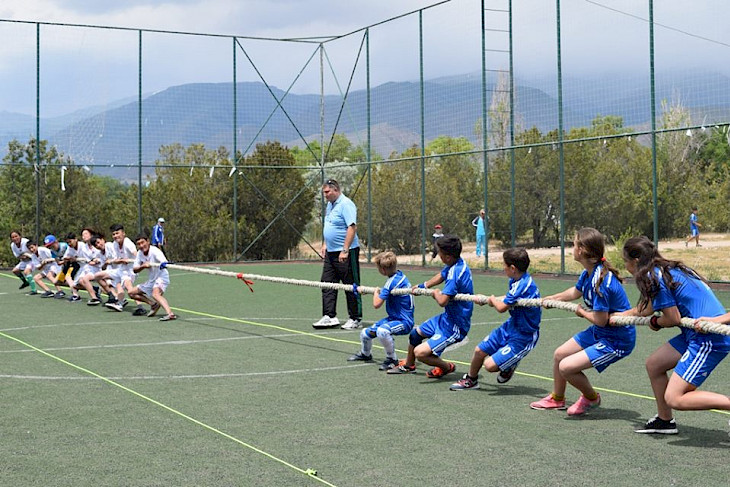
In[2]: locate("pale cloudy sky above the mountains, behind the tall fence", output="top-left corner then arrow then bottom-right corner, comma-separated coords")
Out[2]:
0,0 -> 730,116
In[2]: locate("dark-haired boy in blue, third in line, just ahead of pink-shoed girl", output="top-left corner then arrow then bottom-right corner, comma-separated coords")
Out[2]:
449,248 -> 542,391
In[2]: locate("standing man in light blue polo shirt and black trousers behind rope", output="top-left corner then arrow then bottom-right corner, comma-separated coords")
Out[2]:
312,179 -> 362,330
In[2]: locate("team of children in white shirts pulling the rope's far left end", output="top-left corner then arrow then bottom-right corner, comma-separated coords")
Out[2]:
10,224 -> 177,321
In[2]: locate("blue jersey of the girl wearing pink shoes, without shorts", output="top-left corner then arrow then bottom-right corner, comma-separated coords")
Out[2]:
575,264 -> 636,350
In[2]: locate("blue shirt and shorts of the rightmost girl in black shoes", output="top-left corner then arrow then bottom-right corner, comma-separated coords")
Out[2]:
651,268 -> 730,386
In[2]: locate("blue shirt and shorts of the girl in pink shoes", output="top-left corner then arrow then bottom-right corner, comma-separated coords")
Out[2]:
573,264 -> 636,372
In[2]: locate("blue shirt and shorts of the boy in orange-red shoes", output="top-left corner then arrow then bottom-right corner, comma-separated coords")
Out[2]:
411,258 -> 474,356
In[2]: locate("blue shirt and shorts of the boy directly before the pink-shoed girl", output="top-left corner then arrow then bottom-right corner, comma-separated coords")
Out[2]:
478,272 -> 542,371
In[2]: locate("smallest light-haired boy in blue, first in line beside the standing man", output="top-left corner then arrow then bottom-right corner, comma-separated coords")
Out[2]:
347,252 -> 413,370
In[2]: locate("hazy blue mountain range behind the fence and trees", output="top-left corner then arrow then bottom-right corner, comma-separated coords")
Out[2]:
0,73 -> 730,177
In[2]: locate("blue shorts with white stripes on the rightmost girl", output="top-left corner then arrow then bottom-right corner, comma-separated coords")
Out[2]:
669,334 -> 728,387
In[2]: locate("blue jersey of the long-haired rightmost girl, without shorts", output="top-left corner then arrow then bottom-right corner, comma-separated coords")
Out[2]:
651,267 -> 730,346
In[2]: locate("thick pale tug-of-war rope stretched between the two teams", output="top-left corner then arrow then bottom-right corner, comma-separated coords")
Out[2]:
158,262 -> 730,336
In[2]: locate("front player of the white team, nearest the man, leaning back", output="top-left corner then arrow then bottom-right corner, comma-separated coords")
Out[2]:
129,234 -> 177,321
